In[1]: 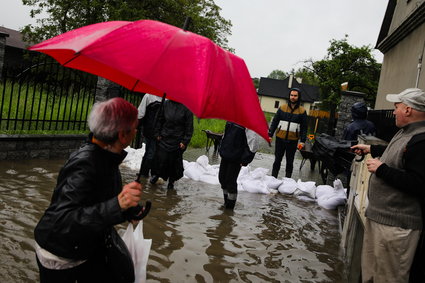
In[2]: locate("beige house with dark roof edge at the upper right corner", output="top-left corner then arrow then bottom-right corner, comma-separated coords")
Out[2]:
375,0 -> 425,110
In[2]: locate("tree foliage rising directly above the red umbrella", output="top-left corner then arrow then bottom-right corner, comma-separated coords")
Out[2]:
22,0 -> 232,48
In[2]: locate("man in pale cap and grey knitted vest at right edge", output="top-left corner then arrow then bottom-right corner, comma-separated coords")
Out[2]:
352,88 -> 425,283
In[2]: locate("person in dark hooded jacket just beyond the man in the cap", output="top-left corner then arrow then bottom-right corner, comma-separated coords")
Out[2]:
342,102 -> 376,140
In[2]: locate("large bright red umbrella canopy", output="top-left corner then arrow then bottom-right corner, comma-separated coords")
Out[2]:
29,20 -> 269,141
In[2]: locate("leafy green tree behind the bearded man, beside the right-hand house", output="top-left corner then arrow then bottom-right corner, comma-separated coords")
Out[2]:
306,35 -> 381,135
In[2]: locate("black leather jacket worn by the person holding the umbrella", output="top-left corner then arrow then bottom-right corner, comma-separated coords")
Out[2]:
34,143 -> 127,259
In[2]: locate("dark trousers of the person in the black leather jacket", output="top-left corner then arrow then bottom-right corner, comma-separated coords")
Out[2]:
36,257 -> 113,283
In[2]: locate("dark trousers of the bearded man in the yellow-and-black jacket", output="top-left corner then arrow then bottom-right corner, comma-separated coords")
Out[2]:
272,137 -> 298,178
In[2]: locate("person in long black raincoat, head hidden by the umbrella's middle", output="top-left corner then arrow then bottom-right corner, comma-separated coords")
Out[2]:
150,100 -> 193,189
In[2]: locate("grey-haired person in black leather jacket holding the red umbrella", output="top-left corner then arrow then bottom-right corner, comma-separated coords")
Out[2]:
34,98 -> 142,283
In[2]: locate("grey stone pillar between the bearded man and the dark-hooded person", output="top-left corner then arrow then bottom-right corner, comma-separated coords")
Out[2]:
335,91 -> 365,139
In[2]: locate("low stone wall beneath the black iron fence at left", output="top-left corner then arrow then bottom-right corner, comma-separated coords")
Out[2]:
0,135 -> 87,160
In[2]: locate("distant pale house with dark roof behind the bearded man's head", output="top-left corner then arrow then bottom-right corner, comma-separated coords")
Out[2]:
258,75 -> 319,114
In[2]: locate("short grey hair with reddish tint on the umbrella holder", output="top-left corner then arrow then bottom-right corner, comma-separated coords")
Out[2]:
87,97 -> 137,144
